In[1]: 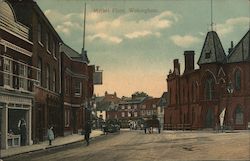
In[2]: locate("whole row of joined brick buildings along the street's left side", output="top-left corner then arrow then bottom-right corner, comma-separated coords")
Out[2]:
0,0 -> 98,149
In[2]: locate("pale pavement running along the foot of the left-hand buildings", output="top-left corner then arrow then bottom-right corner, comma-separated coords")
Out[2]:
0,130 -> 103,158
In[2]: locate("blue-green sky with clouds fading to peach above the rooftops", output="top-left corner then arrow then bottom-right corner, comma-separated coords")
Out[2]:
36,0 -> 250,97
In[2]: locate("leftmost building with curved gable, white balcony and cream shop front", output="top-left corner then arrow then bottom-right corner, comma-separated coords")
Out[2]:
0,1 -> 39,149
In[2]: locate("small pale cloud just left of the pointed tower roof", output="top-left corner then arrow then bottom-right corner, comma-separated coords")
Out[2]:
170,35 -> 200,47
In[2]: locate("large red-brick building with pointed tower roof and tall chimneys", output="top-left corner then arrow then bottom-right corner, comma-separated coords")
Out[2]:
165,31 -> 250,129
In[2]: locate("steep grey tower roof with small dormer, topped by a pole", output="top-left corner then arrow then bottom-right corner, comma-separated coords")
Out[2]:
198,31 -> 226,65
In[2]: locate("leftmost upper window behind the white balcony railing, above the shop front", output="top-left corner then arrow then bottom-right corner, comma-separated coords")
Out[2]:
3,58 -> 12,87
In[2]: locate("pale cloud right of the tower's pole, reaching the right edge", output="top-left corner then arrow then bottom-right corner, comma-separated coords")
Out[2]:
215,17 -> 249,36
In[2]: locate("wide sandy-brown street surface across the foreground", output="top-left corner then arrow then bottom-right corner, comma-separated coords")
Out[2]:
4,130 -> 250,161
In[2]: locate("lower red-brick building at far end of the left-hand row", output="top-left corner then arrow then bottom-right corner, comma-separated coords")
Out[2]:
60,44 -> 95,135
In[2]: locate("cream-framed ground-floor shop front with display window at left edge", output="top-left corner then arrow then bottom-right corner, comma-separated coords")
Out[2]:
0,91 -> 33,149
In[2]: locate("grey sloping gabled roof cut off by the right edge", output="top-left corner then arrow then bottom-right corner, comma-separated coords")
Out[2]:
227,30 -> 250,63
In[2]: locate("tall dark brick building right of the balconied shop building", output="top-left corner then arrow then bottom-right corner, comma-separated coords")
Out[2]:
9,0 -> 63,142
